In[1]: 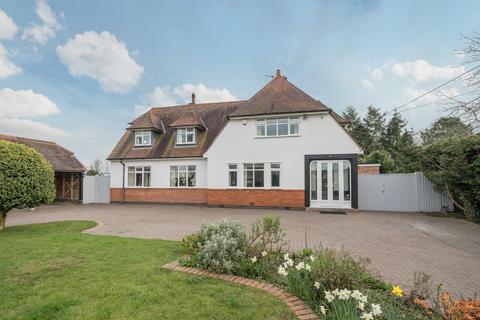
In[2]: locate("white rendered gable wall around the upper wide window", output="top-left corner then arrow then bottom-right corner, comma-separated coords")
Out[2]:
205,114 -> 361,189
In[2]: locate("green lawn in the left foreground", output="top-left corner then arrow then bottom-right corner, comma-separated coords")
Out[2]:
0,221 -> 294,320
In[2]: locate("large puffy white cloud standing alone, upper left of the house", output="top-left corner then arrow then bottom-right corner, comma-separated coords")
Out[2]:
57,31 -> 144,93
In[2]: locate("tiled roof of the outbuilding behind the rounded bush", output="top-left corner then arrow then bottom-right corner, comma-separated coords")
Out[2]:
0,134 -> 86,172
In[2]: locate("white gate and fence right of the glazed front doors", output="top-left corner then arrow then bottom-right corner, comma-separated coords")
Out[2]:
358,172 -> 453,212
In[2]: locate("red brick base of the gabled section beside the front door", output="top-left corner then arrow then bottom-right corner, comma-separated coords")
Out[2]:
207,189 -> 305,208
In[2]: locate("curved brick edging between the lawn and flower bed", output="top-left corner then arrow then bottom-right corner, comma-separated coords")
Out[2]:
162,261 -> 319,320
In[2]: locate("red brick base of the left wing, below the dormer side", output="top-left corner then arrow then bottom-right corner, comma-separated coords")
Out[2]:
110,188 -> 207,204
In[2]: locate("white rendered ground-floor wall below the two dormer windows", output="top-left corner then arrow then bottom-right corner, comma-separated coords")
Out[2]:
110,159 -> 207,188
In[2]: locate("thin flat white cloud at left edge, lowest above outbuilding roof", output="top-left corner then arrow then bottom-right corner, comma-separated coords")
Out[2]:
0,118 -> 67,139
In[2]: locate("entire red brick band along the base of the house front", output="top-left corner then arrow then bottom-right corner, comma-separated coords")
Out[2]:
110,188 -> 305,208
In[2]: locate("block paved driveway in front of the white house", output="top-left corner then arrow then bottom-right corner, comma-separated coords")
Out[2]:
7,204 -> 480,297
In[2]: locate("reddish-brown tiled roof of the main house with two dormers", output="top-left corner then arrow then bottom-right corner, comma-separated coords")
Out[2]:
108,71 -> 344,160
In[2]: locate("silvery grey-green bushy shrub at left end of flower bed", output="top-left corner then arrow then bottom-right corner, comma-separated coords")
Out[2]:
197,220 -> 247,274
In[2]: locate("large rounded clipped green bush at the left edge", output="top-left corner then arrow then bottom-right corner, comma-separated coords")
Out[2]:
0,141 -> 55,230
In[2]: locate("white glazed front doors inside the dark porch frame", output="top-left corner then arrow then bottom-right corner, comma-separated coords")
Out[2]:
310,160 -> 352,208
